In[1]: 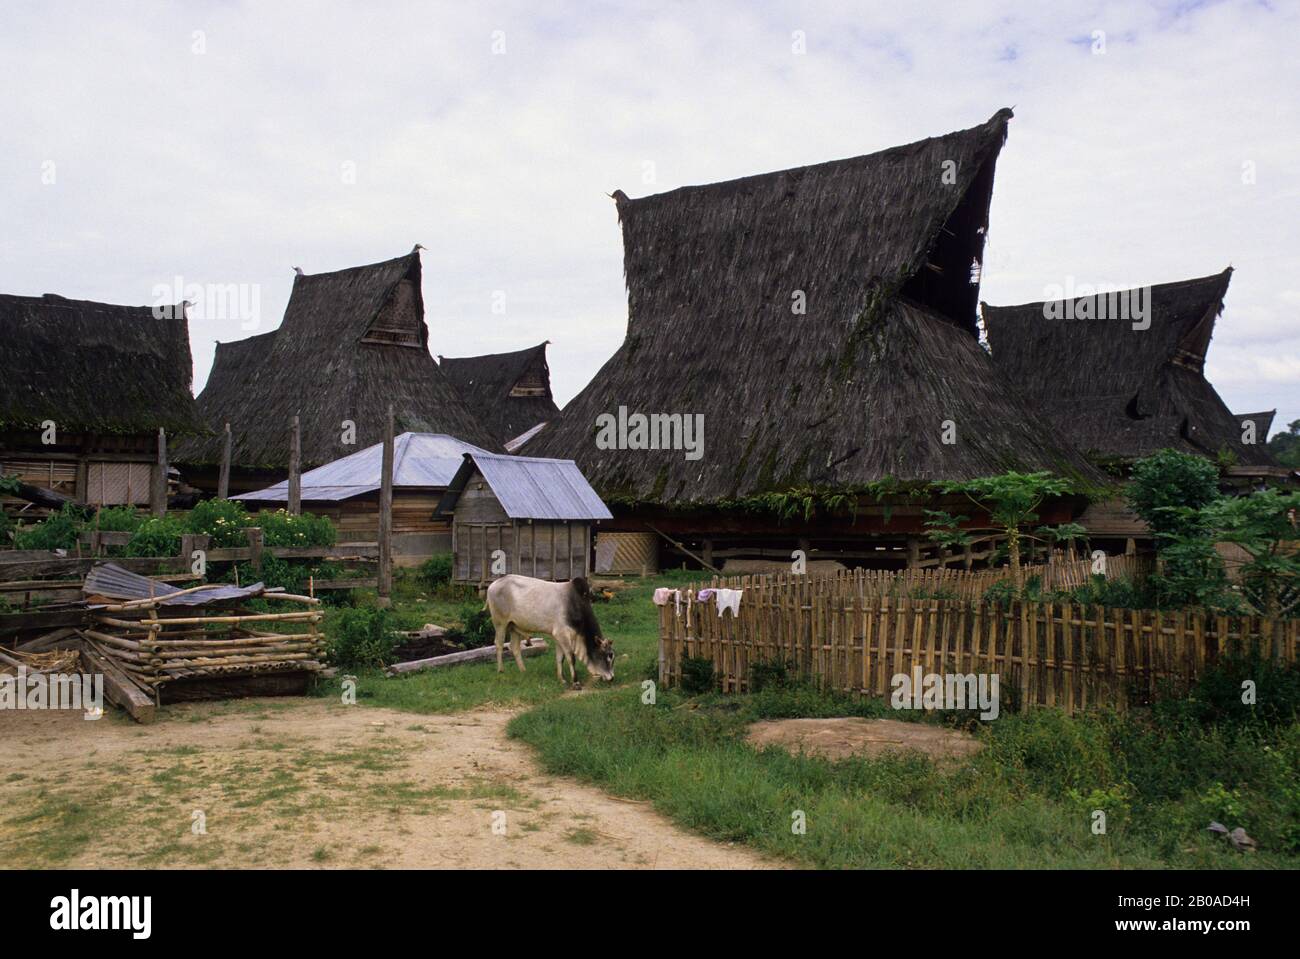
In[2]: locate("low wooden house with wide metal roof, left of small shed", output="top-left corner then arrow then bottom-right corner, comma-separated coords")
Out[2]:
231,433 -> 486,556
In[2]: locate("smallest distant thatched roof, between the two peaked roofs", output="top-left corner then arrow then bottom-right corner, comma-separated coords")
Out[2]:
438,340 -> 560,444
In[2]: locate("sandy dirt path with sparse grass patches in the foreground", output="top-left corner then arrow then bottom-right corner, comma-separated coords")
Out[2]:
0,699 -> 774,869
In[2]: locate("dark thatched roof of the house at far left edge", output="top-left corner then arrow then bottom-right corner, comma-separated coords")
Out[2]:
0,294 -> 203,435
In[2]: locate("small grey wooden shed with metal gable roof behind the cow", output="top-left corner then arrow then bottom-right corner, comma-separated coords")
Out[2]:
438,452 -> 614,582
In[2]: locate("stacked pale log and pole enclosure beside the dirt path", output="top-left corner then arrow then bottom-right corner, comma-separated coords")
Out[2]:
82,593 -> 325,697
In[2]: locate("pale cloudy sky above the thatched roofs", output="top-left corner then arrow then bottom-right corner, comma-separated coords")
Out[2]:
0,0 -> 1300,431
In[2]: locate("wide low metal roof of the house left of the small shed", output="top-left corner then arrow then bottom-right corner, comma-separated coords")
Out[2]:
231,433 -> 486,503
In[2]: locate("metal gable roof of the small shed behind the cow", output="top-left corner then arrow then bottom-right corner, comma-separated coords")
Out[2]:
439,452 -> 614,520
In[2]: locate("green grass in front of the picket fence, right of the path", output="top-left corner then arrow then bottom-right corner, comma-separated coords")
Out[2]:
510,689 -> 1300,868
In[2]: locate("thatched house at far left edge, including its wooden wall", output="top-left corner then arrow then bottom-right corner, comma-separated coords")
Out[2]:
0,294 -> 203,505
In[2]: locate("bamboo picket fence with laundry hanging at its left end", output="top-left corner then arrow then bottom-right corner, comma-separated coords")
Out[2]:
659,557 -> 1300,712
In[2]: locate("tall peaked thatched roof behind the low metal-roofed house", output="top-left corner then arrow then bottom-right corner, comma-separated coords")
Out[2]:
174,252 -> 497,469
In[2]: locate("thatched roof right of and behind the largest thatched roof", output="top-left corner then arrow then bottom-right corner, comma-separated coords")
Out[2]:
984,268 -> 1275,465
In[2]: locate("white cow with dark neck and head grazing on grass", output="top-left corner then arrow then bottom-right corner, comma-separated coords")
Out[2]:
488,574 -> 614,689
